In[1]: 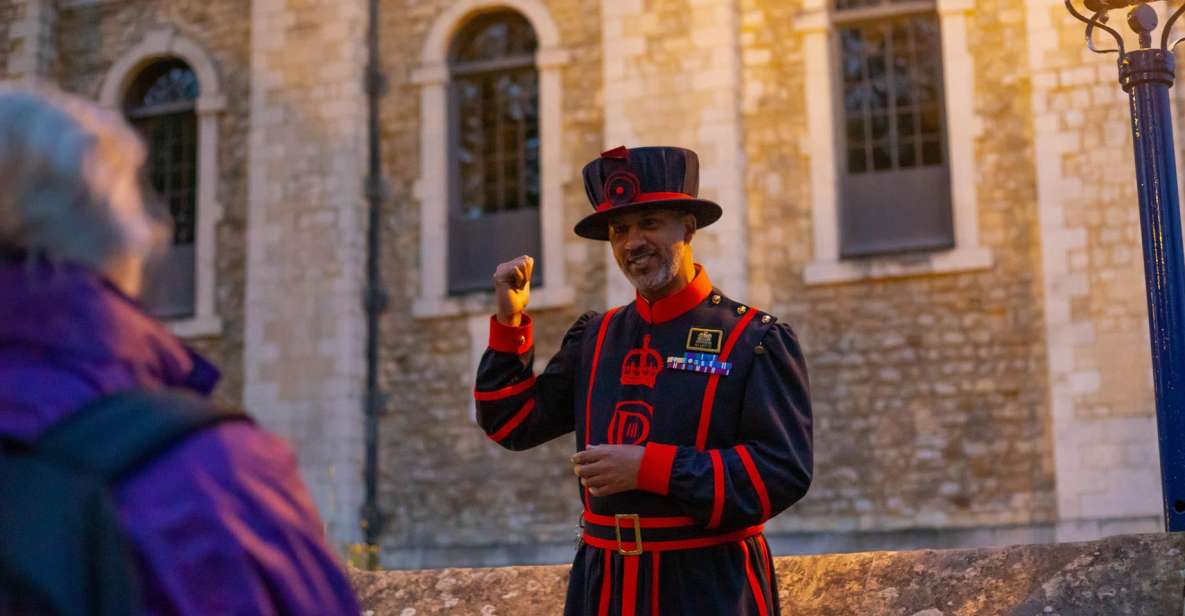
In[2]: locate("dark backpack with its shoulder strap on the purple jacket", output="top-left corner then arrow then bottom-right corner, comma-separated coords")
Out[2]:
0,391 -> 249,616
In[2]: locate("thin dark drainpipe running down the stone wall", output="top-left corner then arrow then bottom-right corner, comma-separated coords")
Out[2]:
360,0 -> 387,571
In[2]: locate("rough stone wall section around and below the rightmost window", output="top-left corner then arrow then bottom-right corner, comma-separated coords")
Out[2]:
739,0 -> 1057,531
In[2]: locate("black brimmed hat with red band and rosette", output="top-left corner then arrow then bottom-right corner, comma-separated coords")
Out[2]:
576,146 -> 723,239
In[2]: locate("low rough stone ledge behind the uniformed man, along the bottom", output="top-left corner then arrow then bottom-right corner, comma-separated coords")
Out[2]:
350,533 -> 1185,616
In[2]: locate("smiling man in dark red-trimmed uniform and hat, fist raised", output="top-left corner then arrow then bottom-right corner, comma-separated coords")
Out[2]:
474,147 -> 812,616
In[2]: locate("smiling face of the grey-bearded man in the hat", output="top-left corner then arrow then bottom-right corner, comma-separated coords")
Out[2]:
609,210 -> 694,294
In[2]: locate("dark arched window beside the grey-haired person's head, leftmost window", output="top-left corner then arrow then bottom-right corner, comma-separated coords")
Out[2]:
123,59 -> 199,319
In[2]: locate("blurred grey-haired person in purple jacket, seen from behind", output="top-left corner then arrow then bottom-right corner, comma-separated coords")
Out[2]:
0,89 -> 359,616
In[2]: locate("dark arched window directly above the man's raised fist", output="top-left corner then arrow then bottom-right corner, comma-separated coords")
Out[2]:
448,11 -> 543,295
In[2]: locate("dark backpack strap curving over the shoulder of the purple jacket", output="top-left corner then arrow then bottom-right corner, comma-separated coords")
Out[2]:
33,391 -> 250,485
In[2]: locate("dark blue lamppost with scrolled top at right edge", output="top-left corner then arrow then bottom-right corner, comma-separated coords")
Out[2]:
1065,0 -> 1185,531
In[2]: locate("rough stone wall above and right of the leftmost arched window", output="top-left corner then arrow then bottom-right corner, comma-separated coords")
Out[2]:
52,0 -> 251,402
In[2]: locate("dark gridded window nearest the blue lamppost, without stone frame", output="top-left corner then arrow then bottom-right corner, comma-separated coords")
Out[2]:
832,0 -> 955,257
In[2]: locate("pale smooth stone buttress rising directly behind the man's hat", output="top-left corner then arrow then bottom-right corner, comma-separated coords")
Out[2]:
601,0 -> 749,304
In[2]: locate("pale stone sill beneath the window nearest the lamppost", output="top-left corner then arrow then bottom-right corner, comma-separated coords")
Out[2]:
802,248 -> 992,285
